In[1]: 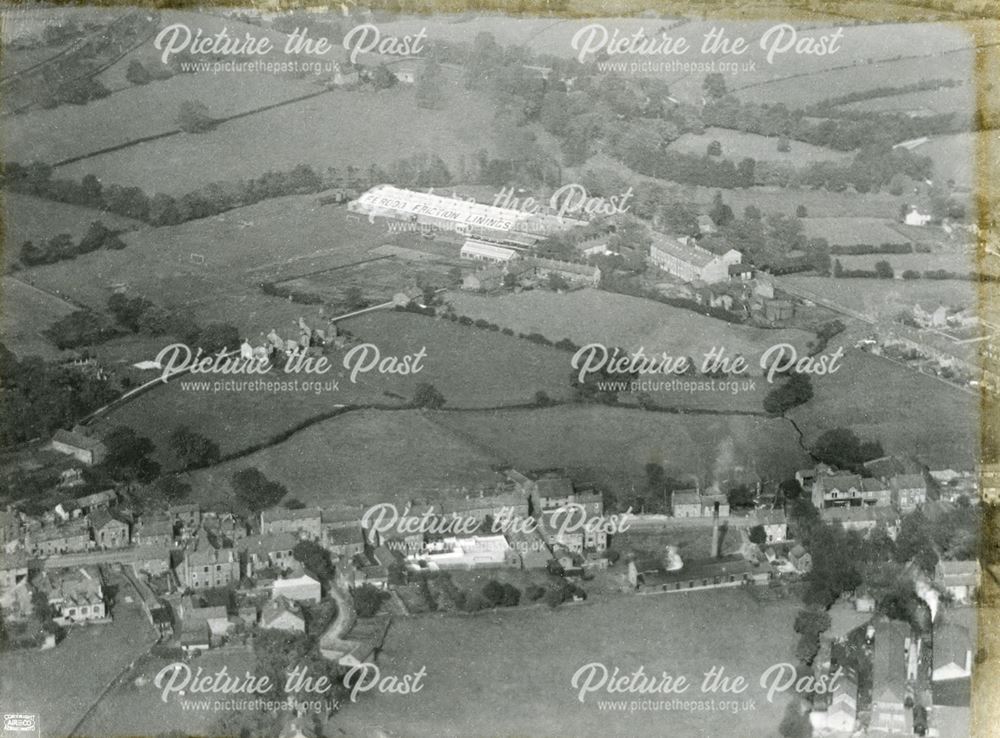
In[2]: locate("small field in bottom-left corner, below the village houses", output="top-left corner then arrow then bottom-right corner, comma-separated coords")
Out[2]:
0,576 -> 155,736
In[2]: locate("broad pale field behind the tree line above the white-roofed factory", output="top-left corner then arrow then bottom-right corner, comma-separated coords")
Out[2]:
52,82 -> 493,195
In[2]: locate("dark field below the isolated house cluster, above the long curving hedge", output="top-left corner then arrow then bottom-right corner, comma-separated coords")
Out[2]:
102,311 -> 570,462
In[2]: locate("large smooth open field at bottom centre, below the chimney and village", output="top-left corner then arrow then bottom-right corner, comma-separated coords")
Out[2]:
334,590 -> 797,738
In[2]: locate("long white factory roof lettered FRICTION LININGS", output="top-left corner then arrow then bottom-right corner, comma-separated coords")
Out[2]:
347,185 -> 584,246
